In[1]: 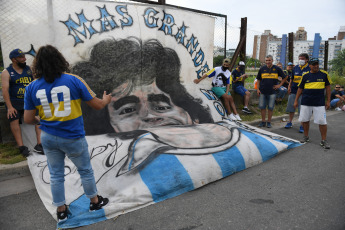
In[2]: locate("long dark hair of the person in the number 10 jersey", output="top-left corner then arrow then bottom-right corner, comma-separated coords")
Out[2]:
32,45 -> 69,83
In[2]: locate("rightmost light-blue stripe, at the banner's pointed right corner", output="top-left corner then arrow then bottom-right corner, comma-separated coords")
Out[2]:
241,130 -> 278,161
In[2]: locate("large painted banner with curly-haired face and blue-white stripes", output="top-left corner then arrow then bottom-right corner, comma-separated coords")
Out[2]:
0,0 -> 300,228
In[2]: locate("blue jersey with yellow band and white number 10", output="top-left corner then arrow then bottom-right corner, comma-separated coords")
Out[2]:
24,73 -> 96,139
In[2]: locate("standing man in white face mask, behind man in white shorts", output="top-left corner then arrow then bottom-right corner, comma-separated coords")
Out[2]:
285,53 -> 310,133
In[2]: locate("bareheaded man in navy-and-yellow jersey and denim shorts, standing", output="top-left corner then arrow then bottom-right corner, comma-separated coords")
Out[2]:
256,55 -> 286,128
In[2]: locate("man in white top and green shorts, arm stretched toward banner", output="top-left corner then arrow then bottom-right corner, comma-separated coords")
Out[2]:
194,59 -> 242,121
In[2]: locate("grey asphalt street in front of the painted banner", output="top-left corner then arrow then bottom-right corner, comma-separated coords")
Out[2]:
0,111 -> 345,230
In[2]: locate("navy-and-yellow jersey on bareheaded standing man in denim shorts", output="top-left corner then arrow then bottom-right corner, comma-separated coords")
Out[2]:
256,65 -> 286,95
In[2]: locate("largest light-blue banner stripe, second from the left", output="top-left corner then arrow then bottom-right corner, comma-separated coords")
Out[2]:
140,154 -> 194,202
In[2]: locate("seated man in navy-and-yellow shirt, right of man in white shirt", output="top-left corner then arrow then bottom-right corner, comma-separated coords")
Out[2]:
232,61 -> 252,114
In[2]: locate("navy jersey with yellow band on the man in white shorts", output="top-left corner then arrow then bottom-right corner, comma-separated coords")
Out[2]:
298,70 -> 332,106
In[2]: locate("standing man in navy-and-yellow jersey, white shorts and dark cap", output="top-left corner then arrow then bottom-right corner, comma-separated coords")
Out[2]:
294,58 -> 331,149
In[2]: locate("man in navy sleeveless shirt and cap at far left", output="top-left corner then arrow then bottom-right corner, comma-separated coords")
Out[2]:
1,49 -> 44,157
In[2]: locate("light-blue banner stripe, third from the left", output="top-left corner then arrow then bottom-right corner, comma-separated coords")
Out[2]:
212,146 -> 246,177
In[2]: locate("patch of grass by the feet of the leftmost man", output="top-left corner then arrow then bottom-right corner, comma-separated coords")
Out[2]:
0,143 -> 26,164
